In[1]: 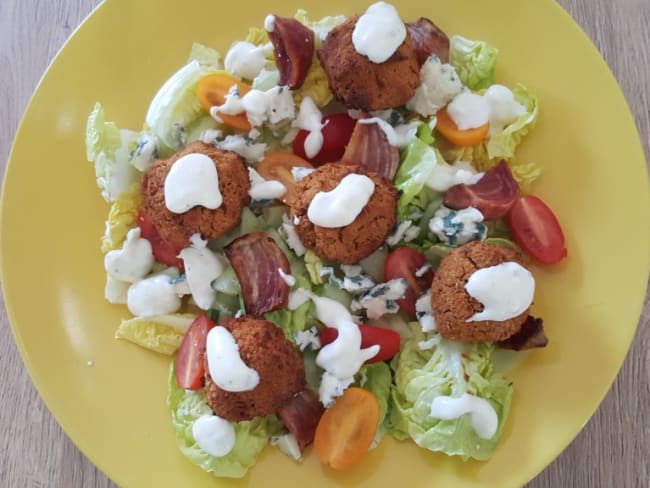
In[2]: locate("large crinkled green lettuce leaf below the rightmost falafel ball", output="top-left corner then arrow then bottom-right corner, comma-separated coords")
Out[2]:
390,323 -> 512,460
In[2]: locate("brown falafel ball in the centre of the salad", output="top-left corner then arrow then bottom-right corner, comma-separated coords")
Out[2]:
287,163 -> 397,264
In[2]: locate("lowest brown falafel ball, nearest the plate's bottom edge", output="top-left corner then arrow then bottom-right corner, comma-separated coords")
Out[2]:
205,315 -> 306,422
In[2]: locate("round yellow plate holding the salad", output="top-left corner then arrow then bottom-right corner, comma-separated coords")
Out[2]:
1,0 -> 650,487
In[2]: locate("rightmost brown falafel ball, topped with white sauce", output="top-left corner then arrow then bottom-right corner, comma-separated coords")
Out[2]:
431,241 -> 529,342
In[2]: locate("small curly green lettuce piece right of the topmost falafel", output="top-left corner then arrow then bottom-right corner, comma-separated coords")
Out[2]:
449,36 -> 499,90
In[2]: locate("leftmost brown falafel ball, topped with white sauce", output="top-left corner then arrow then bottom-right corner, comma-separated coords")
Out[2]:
141,141 -> 250,248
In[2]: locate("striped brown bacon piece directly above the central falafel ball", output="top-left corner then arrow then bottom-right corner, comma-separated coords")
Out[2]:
341,122 -> 399,181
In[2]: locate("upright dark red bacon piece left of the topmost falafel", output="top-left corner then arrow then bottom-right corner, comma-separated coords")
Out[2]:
268,15 -> 314,90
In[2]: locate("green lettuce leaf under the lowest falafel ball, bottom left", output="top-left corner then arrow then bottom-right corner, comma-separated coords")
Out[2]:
167,362 -> 281,478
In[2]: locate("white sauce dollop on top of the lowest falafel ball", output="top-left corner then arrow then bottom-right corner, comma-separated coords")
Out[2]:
205,325 -> 260,392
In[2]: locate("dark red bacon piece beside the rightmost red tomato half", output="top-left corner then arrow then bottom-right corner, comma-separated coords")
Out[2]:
444,161 -> 519,220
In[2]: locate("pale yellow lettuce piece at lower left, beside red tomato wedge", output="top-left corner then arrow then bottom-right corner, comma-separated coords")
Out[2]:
115,313 -> 196,355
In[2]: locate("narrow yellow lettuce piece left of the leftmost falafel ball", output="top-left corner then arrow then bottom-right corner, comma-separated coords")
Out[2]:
102,183 -> 142,253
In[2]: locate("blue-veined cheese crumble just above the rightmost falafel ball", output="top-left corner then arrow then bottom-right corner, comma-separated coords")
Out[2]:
429,206 -> 487,247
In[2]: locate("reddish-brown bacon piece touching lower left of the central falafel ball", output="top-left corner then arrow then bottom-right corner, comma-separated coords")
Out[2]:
225,232 -> 291,316
